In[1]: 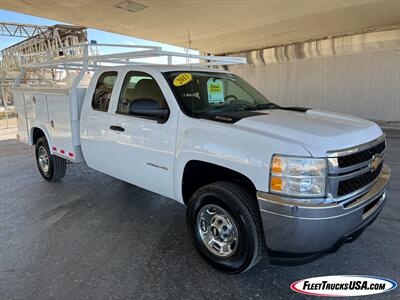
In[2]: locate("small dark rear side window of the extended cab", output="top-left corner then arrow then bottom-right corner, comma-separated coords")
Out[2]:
92,72 -> 118,112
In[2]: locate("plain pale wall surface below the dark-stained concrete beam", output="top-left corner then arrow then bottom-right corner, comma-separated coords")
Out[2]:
230,51 -> 400,121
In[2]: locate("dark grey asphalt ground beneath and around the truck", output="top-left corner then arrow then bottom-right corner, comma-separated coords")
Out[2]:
0,130 -> 400,299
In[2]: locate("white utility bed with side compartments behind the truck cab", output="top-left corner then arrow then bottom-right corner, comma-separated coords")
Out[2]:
13,87 -> 86,161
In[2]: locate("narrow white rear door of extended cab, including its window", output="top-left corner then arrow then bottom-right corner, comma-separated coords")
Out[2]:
80,71 -> 118,174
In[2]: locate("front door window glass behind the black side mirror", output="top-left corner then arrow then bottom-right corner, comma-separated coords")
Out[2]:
117,71 -> 168,114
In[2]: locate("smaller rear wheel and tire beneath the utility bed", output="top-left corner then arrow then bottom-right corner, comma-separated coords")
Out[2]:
35,137 -> 67,182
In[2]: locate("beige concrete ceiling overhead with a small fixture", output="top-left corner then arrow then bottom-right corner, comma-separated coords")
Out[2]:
0,0 -> 400,53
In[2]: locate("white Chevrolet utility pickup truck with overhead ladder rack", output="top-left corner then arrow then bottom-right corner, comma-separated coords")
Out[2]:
13,44 -> 390,273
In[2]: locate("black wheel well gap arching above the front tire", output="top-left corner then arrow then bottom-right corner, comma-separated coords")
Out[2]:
182,160 -> 258,206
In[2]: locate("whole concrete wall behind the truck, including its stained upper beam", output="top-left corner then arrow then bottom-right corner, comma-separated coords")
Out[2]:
229,28 -> 400,121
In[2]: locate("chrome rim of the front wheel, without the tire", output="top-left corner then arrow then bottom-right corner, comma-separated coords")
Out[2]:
197,204 -> 239,257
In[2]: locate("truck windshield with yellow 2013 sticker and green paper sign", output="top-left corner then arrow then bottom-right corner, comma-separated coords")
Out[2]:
165,71 -> 274,117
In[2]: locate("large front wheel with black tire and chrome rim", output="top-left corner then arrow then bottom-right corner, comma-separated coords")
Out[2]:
186,182 -> 264,274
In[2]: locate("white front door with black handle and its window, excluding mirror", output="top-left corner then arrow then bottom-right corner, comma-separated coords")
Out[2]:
108,71 -> 176,198
